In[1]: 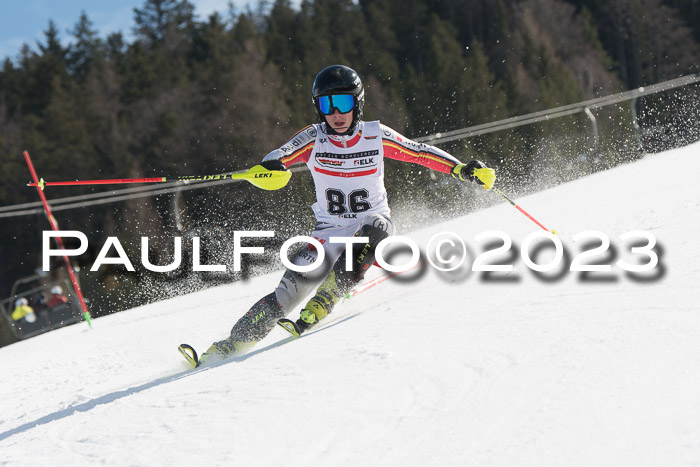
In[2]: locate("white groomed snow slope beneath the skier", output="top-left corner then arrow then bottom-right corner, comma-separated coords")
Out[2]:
0,143 -> 700,466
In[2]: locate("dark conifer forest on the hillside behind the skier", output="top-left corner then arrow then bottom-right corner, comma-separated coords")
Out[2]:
0,0 -> 700,314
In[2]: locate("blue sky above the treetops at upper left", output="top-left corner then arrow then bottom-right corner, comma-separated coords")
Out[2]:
0,0 -> 257,60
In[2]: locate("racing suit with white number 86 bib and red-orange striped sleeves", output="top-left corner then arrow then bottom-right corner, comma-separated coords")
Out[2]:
219,121 -> 460,353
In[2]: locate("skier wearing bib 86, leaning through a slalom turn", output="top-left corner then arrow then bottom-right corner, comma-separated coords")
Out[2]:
200,65 -> 496,362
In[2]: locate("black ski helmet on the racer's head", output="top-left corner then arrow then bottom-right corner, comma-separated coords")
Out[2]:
311,65 -> 365,134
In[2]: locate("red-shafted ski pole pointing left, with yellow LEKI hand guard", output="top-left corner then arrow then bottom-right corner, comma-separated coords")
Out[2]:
27,165 -> 292,190
